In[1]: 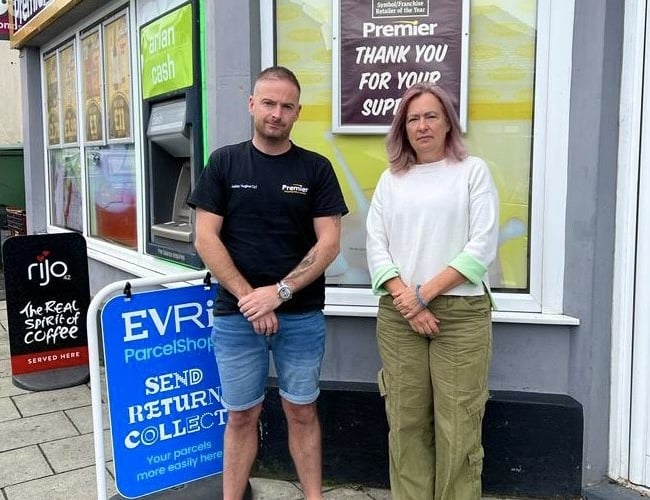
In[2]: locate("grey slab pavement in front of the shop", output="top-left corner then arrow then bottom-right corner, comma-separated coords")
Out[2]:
0,301 -> 520,500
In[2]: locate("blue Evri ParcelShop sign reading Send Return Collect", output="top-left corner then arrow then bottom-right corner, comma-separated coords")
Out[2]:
101,285 -> 227,498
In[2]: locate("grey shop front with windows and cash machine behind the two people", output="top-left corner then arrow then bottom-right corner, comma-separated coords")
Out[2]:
10,0 -> 641,496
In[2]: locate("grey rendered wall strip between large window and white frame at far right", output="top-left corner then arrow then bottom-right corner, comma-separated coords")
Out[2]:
564,0 -> 624,484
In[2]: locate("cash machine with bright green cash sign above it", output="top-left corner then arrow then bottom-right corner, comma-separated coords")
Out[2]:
140,2 -> 203,269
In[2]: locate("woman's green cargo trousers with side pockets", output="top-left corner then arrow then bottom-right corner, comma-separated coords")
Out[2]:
377,294 -> 492,500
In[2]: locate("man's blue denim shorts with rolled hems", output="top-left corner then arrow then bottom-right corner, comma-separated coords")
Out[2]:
212,311 -> 325,411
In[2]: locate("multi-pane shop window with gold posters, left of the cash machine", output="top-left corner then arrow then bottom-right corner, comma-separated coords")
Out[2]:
43,11 -> 137,249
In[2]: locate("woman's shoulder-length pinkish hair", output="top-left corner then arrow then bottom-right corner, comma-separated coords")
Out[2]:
386,82 -> 467,172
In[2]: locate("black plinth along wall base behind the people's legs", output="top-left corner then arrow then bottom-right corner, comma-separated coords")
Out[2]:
253,383 -> 583,499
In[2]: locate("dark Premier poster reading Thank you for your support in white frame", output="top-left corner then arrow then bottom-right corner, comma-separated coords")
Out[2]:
333,0 -> 469,133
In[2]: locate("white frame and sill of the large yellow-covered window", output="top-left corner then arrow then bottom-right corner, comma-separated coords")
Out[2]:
260,0 -> 579,325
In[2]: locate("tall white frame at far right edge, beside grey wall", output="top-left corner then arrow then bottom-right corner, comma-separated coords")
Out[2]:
608,2 -> 650,491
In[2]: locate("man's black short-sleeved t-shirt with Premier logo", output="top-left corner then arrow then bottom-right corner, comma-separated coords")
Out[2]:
187,140 -> 348,314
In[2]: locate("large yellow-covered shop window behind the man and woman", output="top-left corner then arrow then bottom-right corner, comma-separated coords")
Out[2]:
262,0 -> 573,313
